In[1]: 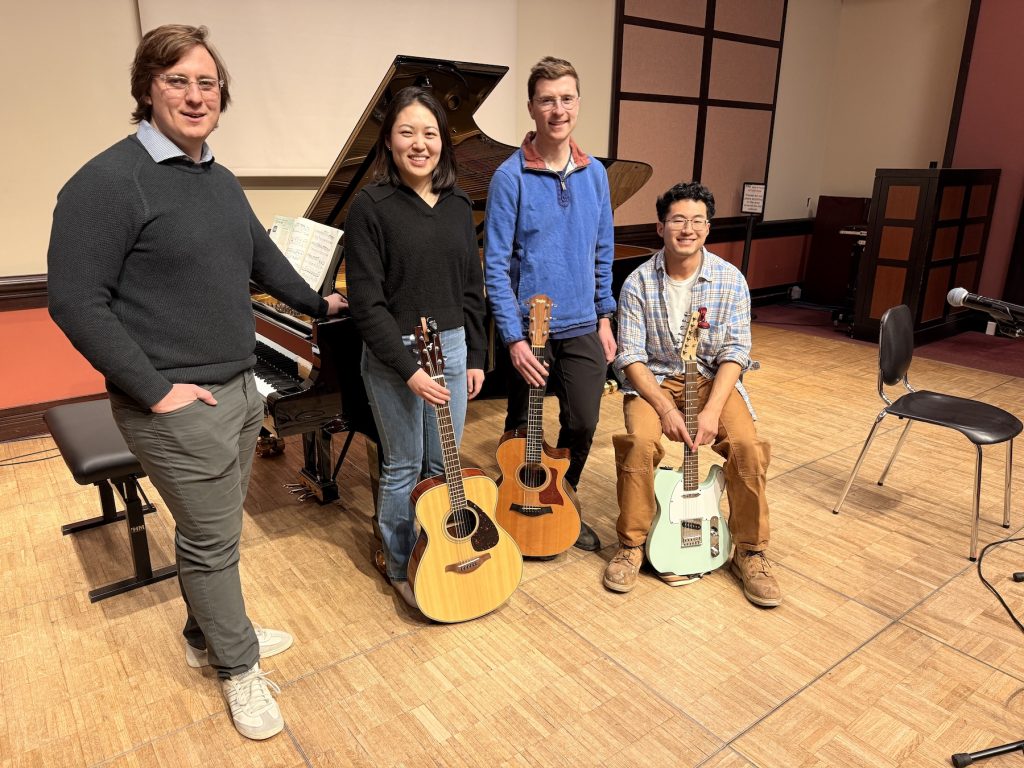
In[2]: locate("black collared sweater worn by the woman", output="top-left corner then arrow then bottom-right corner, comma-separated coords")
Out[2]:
345,184 -> 485,381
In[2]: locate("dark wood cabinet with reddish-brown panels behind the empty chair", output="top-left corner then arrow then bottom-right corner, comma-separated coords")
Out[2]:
853,168 -> 999,343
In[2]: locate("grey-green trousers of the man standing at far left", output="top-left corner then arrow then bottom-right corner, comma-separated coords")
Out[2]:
111,371 -> 263,678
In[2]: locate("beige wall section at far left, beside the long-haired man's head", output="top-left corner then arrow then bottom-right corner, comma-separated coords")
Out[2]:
0,0 -> 138,275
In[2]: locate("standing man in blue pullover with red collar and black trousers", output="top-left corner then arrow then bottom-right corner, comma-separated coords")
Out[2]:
483,56 -> 615,551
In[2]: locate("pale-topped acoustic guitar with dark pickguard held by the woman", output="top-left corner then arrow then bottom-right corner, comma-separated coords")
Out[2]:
409,318 -> 522,624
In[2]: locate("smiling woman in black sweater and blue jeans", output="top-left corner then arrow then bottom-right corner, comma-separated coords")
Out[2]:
345,87 -> 485,605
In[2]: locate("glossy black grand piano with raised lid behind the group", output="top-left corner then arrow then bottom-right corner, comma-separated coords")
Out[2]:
252,56 -> 651,504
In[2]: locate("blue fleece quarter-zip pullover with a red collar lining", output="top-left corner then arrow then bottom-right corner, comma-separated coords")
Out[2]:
483,132 -> 615,345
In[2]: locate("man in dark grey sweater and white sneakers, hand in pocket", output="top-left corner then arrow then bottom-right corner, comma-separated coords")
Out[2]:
47,25 -> 345,738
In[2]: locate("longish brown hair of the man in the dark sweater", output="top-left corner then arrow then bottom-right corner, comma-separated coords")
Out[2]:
131,24 -> 231,123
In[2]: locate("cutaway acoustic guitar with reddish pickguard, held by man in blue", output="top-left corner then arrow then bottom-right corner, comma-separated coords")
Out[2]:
496,294 -> 580,557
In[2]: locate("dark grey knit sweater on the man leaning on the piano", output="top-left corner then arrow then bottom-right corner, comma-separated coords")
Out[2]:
47,136 -> 327,408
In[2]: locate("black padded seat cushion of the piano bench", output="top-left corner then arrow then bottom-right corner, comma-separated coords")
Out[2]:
43,399 -> 143,485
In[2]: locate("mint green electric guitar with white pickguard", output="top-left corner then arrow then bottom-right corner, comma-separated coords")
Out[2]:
647,307 -> 732,584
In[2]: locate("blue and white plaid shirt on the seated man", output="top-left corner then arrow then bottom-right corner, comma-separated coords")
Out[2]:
613,249 -> 757,419
